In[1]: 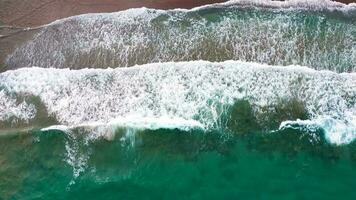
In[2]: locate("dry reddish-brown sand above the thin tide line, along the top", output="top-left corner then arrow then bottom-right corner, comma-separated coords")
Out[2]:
0,0 -> 355,27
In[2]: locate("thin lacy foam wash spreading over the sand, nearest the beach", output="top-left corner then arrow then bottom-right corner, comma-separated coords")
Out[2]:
6,0 -> 356,72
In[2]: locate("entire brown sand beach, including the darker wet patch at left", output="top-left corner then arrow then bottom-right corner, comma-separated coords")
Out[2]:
0,0 -> 356,72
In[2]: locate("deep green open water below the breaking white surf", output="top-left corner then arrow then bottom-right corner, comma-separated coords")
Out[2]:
0,127 -> 356,199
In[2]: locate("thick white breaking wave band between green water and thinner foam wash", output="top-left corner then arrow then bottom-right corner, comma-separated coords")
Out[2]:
0,61 -> 356,144
